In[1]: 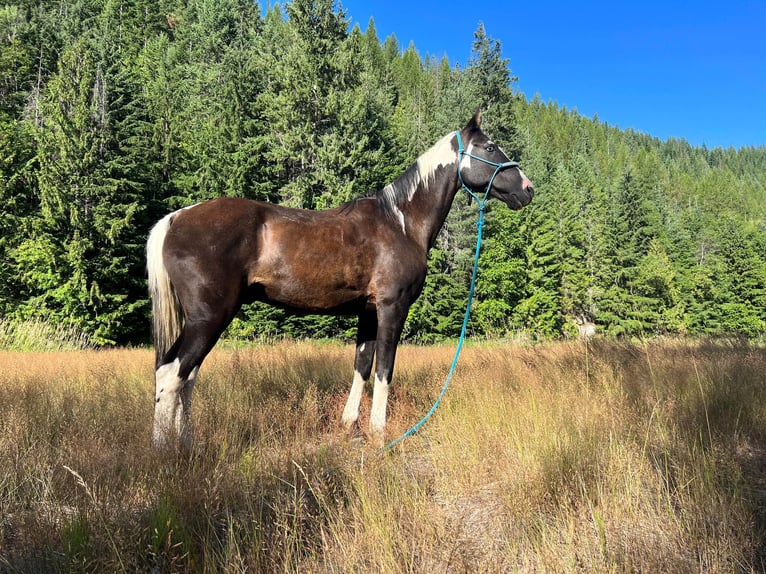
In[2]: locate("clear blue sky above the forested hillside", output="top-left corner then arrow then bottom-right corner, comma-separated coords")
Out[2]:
339,0 -> 766,148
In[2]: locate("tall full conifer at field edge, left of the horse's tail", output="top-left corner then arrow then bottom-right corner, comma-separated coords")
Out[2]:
15,36 -> 142,342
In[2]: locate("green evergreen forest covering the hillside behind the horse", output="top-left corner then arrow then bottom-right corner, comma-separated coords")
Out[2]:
0,0 -> 766,345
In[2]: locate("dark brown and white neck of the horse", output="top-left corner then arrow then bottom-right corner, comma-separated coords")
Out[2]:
383,134 -> 460,250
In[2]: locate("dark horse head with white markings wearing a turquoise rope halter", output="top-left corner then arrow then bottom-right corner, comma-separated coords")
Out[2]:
457,110 -> 535,209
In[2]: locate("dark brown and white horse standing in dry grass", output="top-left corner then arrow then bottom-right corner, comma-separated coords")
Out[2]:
146,110 -> 534,450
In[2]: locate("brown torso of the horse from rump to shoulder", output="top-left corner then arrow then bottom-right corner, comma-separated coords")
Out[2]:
165,198 -> 425,313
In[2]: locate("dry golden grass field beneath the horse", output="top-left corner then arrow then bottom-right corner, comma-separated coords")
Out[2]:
0,340 -> 766,573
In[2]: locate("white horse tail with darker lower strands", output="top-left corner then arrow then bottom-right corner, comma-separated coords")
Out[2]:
146,213 -> 182,366
